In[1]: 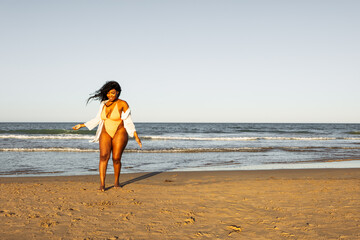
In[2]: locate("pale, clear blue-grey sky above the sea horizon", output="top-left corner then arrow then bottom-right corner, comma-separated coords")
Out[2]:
0,0 -> 360,123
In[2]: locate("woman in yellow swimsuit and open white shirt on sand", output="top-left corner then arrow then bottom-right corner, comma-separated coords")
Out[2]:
73,81 -> 142,191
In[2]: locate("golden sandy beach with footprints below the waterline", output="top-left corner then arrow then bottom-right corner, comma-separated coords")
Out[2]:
0,169 -> 360,239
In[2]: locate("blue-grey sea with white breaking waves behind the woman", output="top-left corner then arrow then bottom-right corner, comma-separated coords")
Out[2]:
0,122 -> 360,177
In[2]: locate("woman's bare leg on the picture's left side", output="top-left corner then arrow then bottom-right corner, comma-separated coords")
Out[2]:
99,127 -> 112,191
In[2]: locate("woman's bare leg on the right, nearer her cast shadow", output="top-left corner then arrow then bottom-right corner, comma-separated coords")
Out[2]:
112,127 -> 128,187
